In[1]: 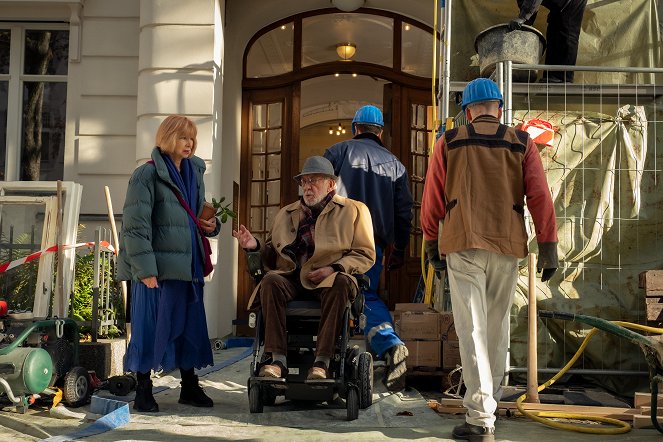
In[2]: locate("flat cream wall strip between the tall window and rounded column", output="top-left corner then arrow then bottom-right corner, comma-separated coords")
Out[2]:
65,0 -> 138,216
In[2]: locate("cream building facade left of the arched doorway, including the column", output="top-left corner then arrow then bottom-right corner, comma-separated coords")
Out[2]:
0,0 -> 234,338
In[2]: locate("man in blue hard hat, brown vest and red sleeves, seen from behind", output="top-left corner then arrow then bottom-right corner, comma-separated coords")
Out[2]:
421,78 -> 559,441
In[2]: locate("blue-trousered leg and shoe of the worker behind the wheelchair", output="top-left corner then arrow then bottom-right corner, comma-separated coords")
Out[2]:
364,244 -> 408,391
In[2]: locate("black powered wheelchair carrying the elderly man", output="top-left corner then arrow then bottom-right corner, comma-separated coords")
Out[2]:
247,252 -> 373,421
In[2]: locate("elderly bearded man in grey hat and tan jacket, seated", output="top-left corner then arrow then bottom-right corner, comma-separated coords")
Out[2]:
233,156 -> 375,420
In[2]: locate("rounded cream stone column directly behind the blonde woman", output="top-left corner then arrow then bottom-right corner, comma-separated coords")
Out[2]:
136,0 -> 226,338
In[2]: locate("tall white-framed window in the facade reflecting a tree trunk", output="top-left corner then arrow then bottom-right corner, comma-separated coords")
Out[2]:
0,22 -> 69,181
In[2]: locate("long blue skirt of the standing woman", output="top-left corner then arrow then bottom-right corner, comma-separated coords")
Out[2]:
124,280 -> 213,373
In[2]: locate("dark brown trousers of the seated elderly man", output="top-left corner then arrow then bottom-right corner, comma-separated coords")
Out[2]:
260,273 -> 356,357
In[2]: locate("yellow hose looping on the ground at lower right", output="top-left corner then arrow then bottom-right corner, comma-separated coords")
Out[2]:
516,321 -> 663,434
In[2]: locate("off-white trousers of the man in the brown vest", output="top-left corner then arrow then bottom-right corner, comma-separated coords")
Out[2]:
447,249 -> 518,427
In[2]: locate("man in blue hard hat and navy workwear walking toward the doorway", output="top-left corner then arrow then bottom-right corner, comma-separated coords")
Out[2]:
324,105 -> 413,391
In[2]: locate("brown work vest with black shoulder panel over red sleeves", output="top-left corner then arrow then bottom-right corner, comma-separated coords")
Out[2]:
440,116 -> 529,258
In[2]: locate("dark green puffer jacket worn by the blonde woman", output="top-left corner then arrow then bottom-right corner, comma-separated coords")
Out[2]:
117,148 -> 221,281
